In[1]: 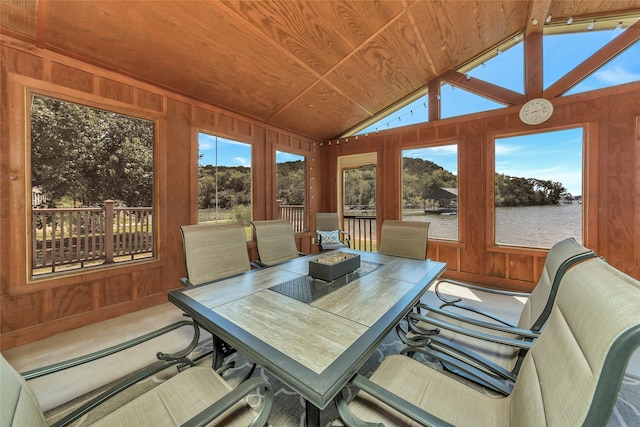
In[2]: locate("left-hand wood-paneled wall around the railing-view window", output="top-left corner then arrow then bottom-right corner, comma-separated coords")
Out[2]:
0,39 -> 320,349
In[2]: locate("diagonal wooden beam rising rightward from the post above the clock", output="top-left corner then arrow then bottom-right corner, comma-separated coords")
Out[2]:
544,21 -> 640,99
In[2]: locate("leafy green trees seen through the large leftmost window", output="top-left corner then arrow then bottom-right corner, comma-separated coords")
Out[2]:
31,96 -> 154,206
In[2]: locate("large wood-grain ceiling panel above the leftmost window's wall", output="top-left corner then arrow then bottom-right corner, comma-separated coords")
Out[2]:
41,1 -> 316,120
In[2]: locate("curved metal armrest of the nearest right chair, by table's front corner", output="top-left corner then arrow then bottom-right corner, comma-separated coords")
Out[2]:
335,374 -> 452,427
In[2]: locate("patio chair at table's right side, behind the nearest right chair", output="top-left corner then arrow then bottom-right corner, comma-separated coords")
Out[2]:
397,238 -> 595,394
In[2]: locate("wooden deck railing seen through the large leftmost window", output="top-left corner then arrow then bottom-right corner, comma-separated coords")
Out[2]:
31,200 -> 154,275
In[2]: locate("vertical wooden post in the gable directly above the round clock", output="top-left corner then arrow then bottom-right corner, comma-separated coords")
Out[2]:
524,0 -> 551,99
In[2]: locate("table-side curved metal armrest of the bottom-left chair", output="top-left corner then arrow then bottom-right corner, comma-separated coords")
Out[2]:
182,378 -> 273,427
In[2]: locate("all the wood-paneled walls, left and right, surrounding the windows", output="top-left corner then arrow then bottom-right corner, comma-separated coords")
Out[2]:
0,39 -> 640,349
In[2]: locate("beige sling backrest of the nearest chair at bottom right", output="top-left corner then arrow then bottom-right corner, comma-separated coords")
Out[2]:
510,258 -> 640,426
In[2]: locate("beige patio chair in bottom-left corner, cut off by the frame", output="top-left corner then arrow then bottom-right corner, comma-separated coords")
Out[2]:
0,321 -> 273,427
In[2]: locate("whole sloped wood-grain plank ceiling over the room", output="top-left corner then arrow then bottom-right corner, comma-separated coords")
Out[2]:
0,0 -> 640,140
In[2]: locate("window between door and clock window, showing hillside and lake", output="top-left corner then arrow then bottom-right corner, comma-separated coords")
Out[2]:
402,144 -> 458,240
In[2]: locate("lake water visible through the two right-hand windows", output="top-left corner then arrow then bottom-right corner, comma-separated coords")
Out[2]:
405,203 -> 582,248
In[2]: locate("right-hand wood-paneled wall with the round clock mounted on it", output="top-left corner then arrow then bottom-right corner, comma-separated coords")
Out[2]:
320,83 -> 640,291
